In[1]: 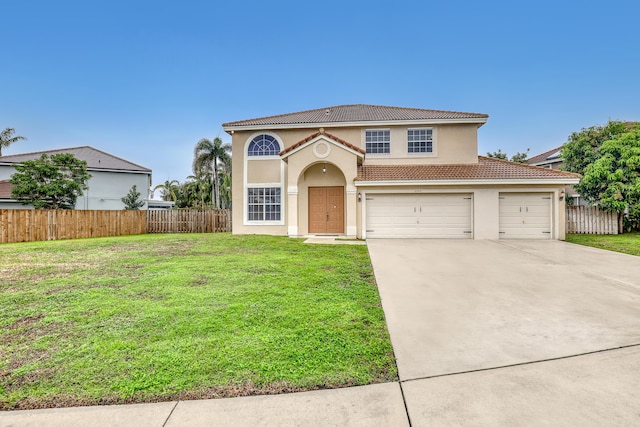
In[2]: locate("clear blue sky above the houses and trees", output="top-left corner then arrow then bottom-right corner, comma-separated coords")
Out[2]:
0,0 -> 640,192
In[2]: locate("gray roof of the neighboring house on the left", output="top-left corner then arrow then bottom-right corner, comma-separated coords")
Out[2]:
0,146 -> 151,173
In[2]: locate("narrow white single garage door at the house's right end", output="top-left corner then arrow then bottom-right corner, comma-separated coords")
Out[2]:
500,193 -> 551,239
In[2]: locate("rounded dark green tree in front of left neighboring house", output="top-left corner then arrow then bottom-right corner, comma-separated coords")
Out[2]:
10,153 -> 91,209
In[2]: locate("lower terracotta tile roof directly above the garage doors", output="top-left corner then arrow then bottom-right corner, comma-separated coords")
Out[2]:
356,156 -> 580,181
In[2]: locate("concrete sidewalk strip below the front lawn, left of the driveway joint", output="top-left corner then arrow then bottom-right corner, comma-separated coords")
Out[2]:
0,383 -> 409,427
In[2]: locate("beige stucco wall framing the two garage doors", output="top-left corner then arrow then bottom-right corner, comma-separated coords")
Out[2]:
357,185 -> 566,240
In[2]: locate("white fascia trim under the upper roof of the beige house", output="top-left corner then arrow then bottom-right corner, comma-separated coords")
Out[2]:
222,117 -> 487,132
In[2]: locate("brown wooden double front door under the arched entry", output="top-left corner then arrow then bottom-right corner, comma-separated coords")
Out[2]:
309,187 -> 344,233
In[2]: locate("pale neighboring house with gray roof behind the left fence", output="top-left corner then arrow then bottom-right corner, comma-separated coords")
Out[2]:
0,147 -> 151,210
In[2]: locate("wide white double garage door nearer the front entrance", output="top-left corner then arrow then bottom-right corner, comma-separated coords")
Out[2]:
366,194 -> 472,239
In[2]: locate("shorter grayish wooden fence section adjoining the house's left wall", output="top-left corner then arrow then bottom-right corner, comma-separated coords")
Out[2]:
147,209 -> 231,233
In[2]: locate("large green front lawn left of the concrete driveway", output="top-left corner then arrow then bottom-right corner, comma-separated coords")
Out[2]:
0,234 -> 397,409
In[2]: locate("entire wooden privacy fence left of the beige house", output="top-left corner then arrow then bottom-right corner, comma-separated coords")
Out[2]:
0,209 -> 231,243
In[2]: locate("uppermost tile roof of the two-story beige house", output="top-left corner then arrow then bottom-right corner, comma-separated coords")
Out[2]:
222,104 -> 489,128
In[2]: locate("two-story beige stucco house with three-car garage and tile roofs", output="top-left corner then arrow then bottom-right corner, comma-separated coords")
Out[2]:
222,104 -> 578,239
